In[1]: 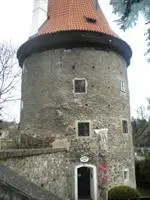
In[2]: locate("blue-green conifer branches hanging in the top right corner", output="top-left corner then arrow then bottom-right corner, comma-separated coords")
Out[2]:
110,0 -> 150,56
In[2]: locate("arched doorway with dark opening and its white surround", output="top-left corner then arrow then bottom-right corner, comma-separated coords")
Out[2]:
75,164 -> 97,200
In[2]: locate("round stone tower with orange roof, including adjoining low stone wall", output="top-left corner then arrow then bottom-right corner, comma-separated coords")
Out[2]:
15,0 -> 135,200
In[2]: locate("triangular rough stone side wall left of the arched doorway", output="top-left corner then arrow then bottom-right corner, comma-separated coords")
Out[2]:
1,153 -> 68,199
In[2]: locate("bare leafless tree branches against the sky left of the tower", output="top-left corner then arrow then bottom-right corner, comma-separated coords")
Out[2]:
0,42 -> 21,119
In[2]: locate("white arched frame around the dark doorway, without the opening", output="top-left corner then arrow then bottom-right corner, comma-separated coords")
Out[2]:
74,163 -> 97,200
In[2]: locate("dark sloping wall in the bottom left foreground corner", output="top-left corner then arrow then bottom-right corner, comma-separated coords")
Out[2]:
0,163 -> 60,200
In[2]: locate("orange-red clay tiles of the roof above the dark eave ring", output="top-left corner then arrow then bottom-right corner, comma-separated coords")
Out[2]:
38,0 -> 117,37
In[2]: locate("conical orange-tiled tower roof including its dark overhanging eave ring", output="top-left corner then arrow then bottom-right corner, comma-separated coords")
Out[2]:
17,0 -> 132,66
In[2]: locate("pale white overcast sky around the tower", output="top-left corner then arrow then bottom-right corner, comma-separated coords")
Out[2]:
0,0 -> 150,122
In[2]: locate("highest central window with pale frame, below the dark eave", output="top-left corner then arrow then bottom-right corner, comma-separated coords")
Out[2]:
74,79 -> 86,93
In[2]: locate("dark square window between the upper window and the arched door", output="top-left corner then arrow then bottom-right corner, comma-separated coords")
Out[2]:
78,122 -> 90,136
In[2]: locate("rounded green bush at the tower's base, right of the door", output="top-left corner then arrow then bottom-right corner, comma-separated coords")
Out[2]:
108,185 -> 139,199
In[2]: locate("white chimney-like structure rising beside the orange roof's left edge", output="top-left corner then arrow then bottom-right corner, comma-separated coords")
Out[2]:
31,0 -> 48,35
